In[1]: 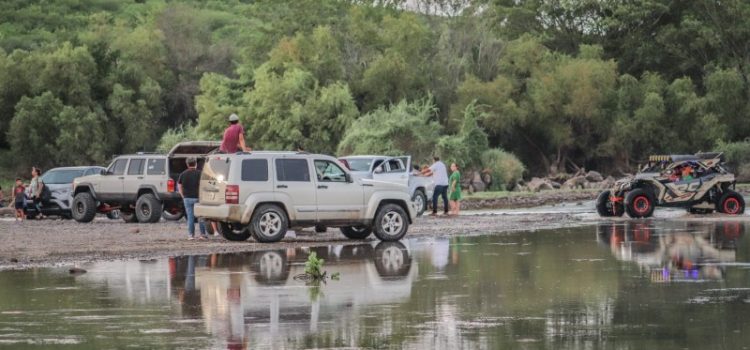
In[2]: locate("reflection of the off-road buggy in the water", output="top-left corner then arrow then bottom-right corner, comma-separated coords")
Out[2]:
597,222 -> 745,282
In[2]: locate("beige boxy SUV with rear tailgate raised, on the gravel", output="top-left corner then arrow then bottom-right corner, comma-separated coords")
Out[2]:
71,141 -> 219,223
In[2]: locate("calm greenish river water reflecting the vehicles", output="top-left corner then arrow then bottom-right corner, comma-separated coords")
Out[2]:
0,220 -> 750,350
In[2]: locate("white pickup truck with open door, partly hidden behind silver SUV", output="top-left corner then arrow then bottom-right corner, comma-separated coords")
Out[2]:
339,155 -> 435,216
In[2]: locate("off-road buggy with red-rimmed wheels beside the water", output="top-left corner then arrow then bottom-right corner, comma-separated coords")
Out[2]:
596,153 -> 745,218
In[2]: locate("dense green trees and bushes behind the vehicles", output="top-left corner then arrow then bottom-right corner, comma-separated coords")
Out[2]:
0,0 -> 750,176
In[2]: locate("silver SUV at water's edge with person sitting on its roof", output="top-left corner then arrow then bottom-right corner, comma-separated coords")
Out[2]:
195,152 -> 416,242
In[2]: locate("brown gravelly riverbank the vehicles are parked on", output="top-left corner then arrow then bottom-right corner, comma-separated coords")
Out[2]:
0,213 -> 583,269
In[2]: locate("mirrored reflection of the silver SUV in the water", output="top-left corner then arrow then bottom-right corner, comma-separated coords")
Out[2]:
170,242 -> 417,348
